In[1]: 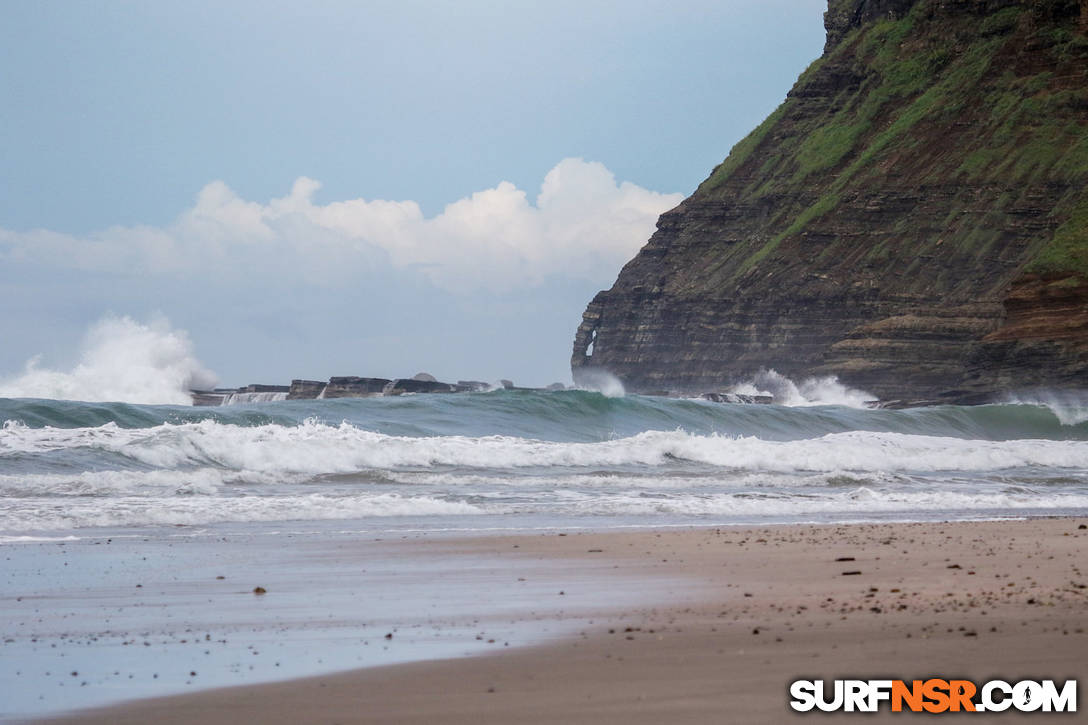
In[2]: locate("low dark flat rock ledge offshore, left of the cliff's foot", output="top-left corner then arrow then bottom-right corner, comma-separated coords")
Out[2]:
189,372 -> 566,406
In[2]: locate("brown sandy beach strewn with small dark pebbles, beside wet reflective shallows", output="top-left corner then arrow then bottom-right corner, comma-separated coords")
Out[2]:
27,518 -> 1088,724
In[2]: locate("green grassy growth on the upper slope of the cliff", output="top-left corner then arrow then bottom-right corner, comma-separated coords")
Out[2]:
695,0 -> 1088,282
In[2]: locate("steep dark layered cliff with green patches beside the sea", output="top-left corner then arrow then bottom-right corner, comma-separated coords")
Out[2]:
571,0 -> 1088,401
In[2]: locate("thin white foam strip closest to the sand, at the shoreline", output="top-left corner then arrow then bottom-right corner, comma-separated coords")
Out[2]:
8,478 -> 1088,531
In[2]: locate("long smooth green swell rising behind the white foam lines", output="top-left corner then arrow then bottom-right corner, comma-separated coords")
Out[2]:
0,390 -> 1088,442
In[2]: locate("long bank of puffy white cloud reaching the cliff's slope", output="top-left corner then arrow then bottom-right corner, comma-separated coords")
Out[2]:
0,159 -> 682,292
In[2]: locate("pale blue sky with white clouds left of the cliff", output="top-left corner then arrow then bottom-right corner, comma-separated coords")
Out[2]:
0,0 -> 826,390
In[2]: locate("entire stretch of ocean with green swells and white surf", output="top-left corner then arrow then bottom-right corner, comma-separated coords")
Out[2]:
0,390 -> 1088,535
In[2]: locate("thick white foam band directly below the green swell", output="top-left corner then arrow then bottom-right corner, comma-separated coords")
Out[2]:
0,419 -> 1088,474
